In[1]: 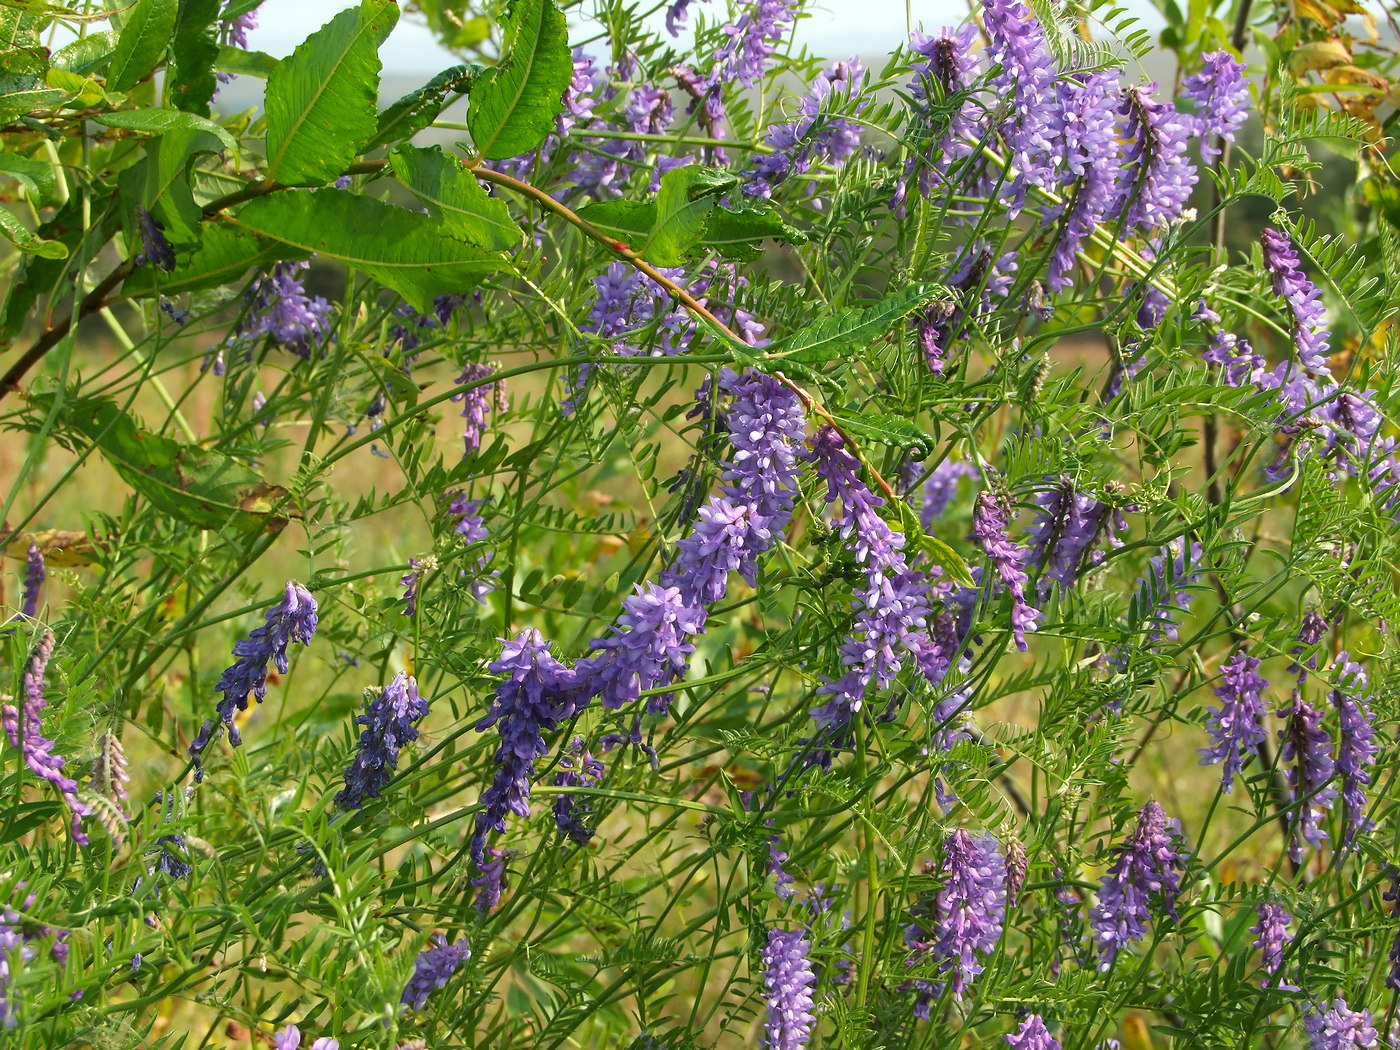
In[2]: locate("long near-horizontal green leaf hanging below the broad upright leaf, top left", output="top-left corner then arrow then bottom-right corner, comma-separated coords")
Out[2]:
224,189 -> 505,314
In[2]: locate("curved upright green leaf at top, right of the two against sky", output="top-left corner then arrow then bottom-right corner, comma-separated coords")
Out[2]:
466,0 -> 574,161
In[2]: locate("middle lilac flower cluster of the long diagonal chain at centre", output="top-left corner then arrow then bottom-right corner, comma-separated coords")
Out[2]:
581,582 -> 704,714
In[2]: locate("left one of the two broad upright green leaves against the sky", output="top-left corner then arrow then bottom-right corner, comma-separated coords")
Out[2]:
266,0 -> 399,186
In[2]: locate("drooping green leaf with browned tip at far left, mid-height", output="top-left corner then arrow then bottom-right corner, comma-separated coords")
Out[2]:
31,393 -> 300,532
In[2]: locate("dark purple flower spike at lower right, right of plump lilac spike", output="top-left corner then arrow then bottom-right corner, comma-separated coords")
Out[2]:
1089,802 -> 1184,970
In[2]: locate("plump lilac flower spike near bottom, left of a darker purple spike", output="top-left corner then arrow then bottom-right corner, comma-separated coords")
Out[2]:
934,829 -> 1007,998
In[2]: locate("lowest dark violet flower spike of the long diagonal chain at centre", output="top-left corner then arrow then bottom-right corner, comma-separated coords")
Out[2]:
470,627 -> 575,896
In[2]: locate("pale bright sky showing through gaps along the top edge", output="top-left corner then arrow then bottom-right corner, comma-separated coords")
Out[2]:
248,0 -> 1159,78
